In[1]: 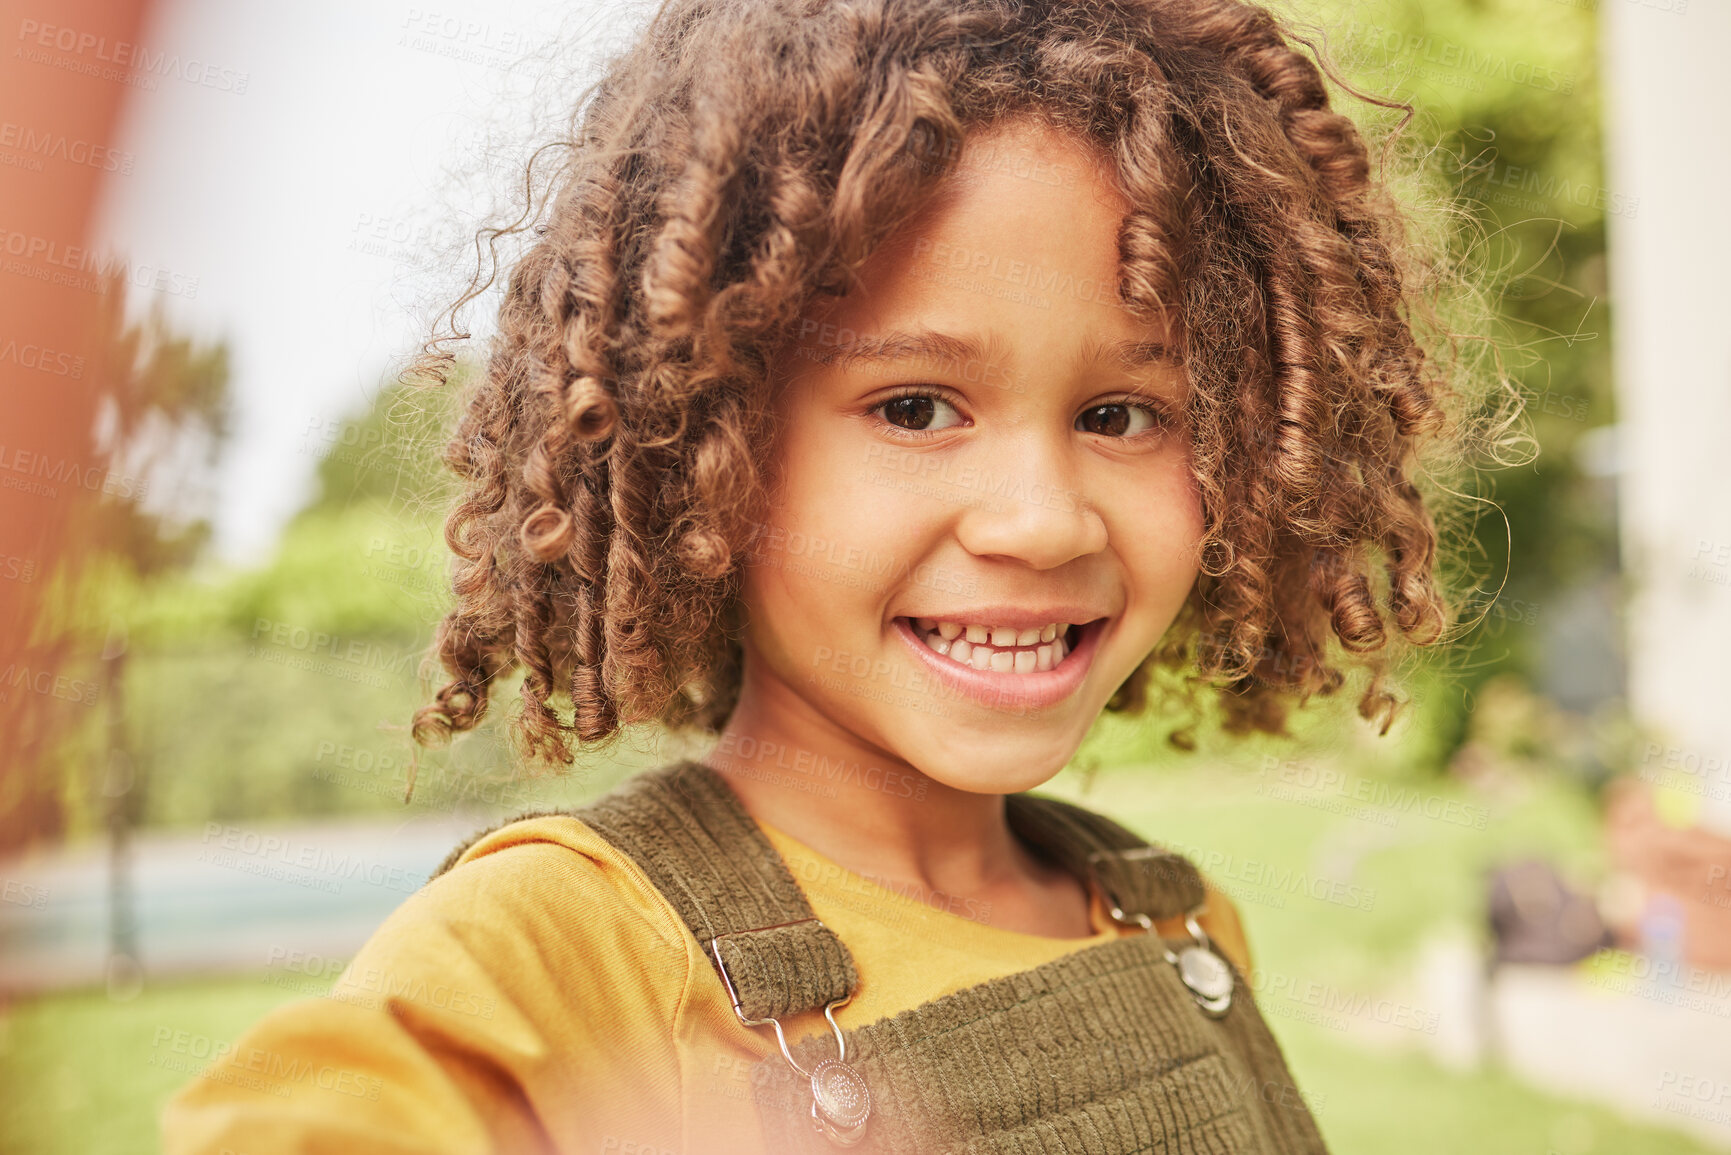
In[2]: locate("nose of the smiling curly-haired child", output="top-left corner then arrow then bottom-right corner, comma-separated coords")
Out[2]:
956,438 -> 1106,570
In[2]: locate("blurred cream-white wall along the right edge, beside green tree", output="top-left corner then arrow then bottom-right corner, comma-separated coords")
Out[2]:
1599,0 -> 1731,835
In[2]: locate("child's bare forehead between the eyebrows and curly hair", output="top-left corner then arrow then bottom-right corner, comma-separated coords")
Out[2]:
807,119 -> 1172,358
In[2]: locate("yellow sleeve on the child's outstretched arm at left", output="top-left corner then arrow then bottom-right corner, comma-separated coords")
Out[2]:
161,823 -> 687,1155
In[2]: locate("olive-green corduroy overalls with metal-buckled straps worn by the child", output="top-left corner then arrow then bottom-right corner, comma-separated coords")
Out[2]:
434,762 -> 1328,1155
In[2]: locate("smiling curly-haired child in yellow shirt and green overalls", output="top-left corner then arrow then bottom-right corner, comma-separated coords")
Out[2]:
164,0 -> 1447,1155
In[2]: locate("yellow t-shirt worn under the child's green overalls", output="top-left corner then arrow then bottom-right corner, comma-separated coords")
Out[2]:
163,816 -> 1250,1155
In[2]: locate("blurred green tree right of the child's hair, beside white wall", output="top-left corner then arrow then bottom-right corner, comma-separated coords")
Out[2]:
1204,0 -> 1606,769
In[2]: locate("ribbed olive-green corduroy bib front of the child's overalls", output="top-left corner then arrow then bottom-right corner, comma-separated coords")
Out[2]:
753,935 -> 1326,1155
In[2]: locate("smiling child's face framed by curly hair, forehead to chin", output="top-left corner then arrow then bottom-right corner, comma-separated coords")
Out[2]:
743,123 -> 1203,793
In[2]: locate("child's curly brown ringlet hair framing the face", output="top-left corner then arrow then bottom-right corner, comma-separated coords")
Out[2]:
401,0 -> 1456,775
